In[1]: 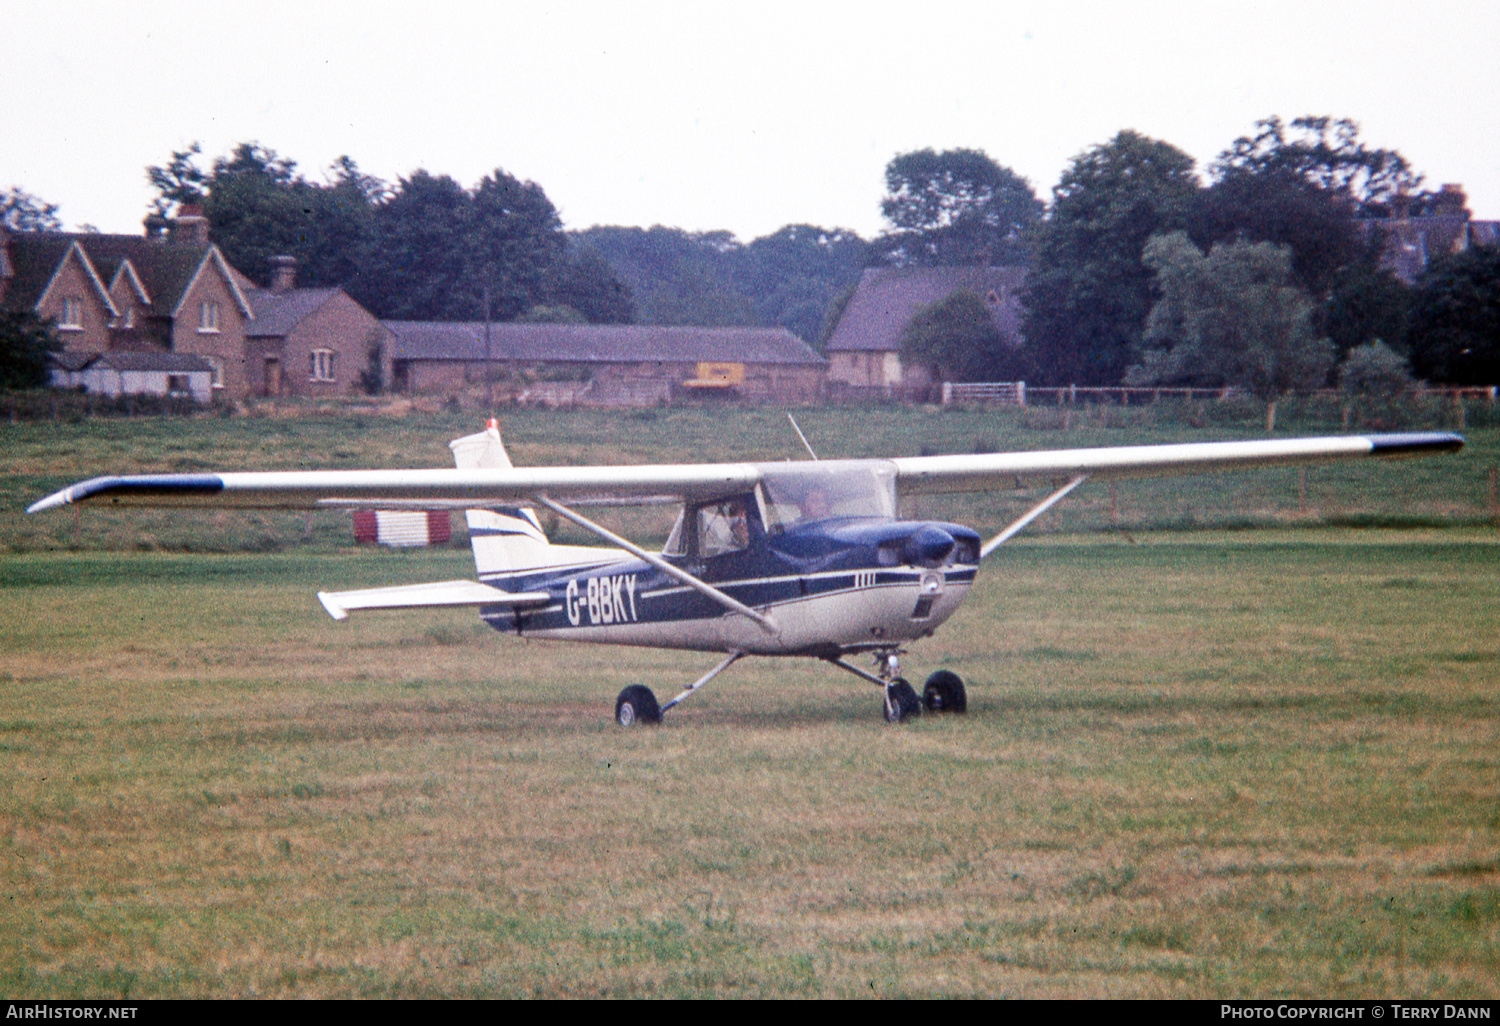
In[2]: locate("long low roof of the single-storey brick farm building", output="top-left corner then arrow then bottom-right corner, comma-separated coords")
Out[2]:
381,321 -> 827,366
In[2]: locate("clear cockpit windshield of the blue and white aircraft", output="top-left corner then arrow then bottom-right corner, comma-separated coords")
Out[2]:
761,461 -> 896,534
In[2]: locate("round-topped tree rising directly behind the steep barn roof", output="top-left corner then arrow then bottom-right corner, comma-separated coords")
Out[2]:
876,149 -> 1043,267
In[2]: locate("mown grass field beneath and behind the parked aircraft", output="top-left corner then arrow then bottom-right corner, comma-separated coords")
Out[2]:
0,411 -> 1500,998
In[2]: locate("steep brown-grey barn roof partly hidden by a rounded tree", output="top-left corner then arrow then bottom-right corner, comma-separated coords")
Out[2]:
825,267 -> 1026,353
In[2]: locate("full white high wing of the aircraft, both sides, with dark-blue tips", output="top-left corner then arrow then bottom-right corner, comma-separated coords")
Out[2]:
27,432 -> 1464,513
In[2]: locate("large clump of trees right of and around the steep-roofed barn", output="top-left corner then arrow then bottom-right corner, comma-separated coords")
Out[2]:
875,117 -> 1500,404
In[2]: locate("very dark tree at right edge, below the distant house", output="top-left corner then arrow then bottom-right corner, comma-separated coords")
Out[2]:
1407,246 -> 1500,386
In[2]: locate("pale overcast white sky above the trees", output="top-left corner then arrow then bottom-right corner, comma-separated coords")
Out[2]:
0,0 -> 1500,242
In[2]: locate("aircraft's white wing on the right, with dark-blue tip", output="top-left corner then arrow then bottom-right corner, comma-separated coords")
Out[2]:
891,432 -> 1464,495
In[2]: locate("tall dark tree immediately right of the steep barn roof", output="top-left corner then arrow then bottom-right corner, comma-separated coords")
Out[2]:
1022,132 -> 1199,386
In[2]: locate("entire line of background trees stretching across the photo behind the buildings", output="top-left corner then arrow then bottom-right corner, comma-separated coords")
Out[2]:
0,117 -> 1500,401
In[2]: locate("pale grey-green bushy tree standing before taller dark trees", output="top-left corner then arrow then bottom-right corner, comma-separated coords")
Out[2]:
1127,231 -> 1334,432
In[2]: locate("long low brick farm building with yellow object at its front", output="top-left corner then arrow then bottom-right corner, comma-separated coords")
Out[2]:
384,321 -> 828,407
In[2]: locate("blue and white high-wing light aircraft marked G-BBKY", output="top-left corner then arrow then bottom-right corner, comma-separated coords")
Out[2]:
29,420 -> 1464,726
